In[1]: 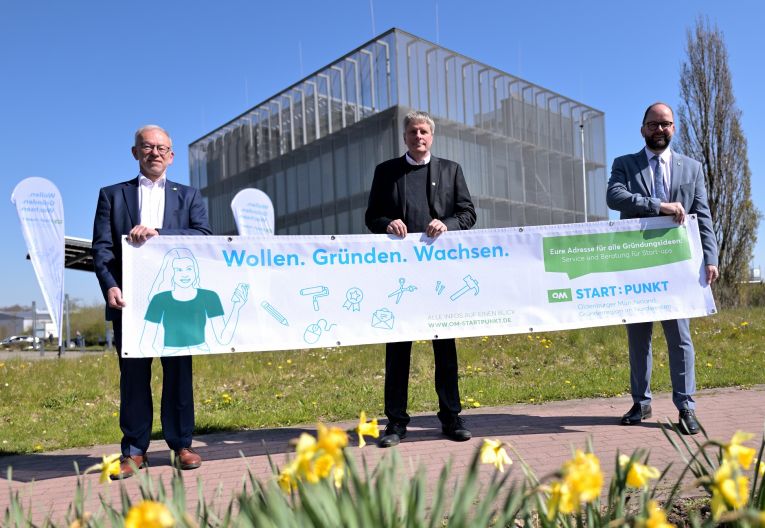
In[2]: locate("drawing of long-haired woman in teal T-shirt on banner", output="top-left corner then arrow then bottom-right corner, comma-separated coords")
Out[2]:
140,248 -> 249,356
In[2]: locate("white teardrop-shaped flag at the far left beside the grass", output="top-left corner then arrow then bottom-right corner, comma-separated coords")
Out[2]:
11,177 -> 65,346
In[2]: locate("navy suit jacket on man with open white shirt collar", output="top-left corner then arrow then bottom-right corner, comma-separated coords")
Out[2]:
91,177 -> 212,321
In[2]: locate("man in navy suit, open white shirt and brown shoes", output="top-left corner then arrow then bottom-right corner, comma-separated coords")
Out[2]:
93,125 -> 212,479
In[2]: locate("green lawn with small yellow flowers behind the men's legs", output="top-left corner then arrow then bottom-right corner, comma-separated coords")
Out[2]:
0,308 -> 765,455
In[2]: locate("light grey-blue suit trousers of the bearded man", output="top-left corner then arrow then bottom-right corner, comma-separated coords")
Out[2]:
627,319 -> 696,410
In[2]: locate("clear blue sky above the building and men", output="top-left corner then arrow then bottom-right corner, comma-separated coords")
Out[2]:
0,0 -> 765,306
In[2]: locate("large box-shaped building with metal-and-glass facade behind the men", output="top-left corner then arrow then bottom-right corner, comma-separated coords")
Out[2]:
189,29 -> 608,235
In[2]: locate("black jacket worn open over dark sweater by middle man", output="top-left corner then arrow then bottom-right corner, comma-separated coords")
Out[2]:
365,156 -> 476,233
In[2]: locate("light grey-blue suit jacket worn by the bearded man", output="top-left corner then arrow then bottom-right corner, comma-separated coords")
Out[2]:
606,149 -> 717,266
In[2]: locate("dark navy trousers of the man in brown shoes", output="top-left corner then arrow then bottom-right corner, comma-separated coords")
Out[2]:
113,319 -> 194,455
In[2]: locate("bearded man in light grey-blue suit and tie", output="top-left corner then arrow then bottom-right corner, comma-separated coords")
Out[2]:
606,103 -> 719,434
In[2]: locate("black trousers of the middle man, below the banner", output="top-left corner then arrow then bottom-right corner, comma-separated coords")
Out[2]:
385,339 -> 462,426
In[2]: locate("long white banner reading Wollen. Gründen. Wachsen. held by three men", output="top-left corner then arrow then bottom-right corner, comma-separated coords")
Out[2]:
123,216 -> 716,357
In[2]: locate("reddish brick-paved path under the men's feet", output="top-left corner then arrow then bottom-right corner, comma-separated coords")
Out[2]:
0,386 -> 765,522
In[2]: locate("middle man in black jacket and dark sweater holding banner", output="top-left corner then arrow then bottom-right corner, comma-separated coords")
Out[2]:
366,112 -> 476,447
